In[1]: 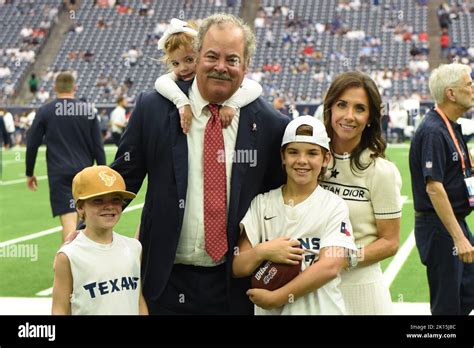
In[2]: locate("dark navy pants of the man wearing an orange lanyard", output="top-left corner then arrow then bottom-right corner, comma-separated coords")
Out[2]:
415,214 -> 474,315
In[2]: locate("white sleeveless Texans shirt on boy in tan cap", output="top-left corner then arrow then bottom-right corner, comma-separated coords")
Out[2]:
58,231 -> 142,315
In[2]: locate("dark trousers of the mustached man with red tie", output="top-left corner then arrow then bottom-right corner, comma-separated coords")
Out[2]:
147,263 -> 230,315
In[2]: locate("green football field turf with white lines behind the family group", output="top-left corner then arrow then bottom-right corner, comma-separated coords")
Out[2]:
0,144 -> 473,302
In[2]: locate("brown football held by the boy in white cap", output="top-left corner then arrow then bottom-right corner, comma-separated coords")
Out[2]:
252,261 -> 301,291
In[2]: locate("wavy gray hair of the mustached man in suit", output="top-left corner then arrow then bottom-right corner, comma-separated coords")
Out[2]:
194,13 -> 255,67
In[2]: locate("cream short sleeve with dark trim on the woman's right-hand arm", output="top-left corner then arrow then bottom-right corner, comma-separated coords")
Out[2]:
369,158 -> 402,220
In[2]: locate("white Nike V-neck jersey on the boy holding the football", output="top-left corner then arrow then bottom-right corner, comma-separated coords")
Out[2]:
241,186 -> 356,315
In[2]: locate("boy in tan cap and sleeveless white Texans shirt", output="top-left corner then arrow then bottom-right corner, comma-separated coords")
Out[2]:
52,166 -> 148,315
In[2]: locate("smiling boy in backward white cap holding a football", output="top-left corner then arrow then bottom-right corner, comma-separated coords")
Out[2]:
232,116 -> 357,315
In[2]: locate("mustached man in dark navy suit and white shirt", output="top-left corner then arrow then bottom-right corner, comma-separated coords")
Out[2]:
112,14 -> 288,314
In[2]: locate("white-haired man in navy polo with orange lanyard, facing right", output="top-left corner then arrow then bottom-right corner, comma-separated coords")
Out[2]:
410,64 -> 474,315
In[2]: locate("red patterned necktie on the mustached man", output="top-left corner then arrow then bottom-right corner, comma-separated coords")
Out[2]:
203,104 -> 227,261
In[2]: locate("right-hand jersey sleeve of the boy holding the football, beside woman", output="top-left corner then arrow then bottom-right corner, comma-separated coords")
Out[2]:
320,196 -> 357,250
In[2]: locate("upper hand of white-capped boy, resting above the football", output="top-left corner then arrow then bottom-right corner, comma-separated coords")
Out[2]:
255,237 -> 304,265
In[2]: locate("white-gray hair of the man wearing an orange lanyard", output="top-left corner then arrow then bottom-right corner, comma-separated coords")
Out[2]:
428,63 -> 472,104
